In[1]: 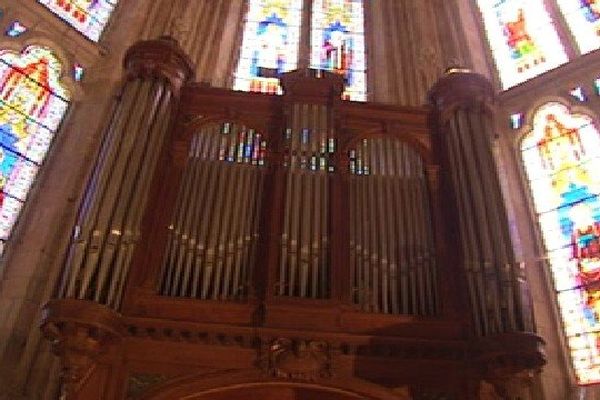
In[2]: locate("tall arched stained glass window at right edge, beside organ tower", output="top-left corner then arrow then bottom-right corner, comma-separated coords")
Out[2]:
521,102 -> 600,384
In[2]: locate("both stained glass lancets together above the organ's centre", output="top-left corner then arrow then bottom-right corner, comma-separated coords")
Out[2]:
233,0 -> 366,101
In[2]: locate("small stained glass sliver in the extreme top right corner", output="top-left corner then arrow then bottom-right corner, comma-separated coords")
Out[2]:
557,0 -> 600,54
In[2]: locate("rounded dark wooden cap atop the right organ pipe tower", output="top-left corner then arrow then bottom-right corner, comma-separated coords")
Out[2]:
429,68 -> 495,113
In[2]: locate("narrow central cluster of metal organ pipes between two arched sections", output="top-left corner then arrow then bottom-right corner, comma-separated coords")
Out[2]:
276,103 -> 334,299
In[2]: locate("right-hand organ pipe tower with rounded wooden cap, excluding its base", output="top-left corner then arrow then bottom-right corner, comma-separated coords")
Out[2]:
430,71 -> 533,336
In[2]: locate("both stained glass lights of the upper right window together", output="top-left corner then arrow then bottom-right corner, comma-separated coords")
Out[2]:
477,0 -> 600,89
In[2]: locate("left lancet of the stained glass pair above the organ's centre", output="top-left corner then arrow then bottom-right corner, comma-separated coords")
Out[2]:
233,0 -> 302,94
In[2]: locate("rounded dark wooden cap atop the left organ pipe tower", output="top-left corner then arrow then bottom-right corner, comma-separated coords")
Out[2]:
123,36 -> 194,91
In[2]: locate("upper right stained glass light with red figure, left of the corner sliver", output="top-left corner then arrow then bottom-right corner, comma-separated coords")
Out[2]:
477,0 -> 568,89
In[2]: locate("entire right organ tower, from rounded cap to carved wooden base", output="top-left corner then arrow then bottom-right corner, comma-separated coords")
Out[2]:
430,69 -> 545,398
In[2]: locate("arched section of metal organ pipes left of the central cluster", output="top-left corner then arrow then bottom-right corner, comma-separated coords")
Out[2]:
159,123 -> 266,300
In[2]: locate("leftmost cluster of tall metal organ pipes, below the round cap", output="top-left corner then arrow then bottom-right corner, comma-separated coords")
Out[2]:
57,67 -> 180,309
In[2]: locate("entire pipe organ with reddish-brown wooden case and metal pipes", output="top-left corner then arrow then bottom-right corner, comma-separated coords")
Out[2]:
42,38 -> 544,399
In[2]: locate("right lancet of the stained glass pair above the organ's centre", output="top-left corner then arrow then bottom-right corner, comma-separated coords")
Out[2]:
311,0 -> 366,101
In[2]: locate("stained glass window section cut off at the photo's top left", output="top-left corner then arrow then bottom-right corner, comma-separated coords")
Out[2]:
38,0 -> 119,42
